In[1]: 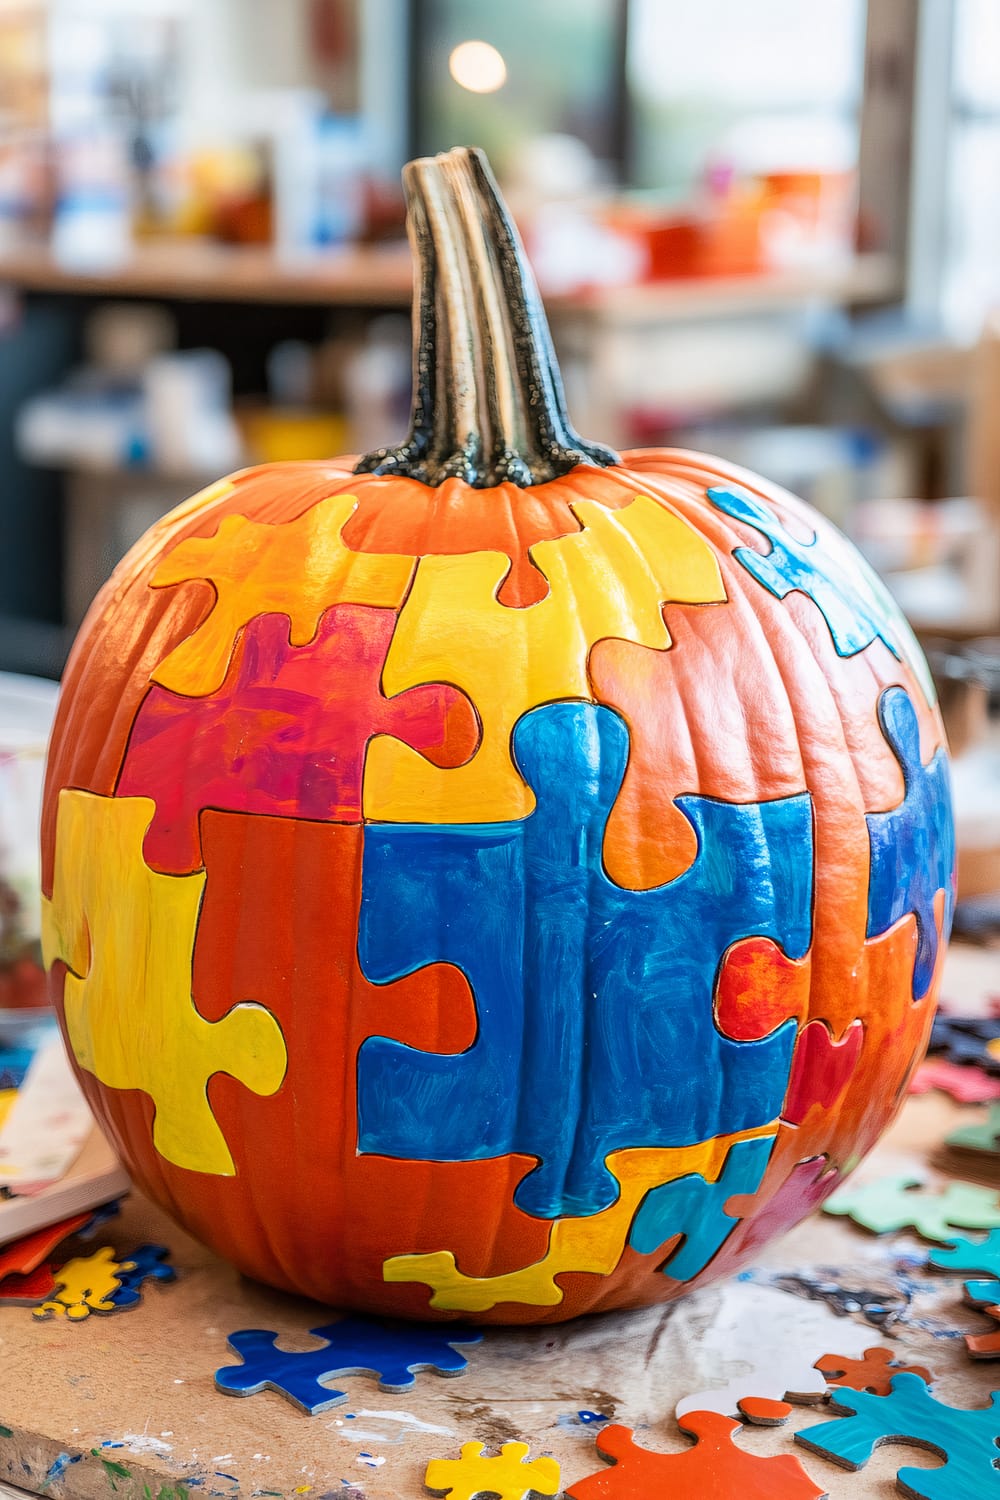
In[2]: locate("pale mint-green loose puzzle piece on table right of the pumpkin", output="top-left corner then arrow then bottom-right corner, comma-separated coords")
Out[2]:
823,1176 -> 1000,1242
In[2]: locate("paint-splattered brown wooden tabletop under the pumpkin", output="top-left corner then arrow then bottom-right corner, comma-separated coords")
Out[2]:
0,942 -> 1000,1500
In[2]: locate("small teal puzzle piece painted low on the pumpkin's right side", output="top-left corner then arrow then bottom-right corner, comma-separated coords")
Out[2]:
628,1136 -> 774,1281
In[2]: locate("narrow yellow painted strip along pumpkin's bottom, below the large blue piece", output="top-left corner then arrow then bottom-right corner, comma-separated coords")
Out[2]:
382,1125 -> 775,1313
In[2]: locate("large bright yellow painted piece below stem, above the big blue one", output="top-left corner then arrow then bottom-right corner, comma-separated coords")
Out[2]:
364,495 -> 726,824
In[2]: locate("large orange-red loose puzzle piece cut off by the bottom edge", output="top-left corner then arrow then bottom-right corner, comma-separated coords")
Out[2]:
565,1412 -> 826,1500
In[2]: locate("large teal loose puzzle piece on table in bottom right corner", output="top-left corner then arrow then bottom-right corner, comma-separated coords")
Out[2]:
795,1374 -> 1000,1500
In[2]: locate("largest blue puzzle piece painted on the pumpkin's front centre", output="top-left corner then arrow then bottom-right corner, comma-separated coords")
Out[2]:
358,702 -> 813,1218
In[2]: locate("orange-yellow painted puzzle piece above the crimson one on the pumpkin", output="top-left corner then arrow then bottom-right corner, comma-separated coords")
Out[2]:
151,495 -> 414,698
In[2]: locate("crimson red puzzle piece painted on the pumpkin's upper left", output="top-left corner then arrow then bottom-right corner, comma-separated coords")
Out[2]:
117,605 -> 480,873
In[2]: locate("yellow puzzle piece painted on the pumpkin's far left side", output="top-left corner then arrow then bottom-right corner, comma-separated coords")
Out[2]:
42,789 -> 288,1176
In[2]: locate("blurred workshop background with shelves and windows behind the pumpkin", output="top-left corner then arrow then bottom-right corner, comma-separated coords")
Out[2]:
0,0 -> 1000,921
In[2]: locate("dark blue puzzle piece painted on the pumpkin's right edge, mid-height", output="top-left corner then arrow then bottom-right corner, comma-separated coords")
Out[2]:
865,687 -> 955,1001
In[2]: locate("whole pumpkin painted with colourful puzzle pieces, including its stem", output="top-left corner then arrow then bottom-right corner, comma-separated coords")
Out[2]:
43,152 -> 954,1323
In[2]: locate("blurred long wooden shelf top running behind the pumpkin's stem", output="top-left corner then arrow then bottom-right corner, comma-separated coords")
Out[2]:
0,242 -> 900,323
